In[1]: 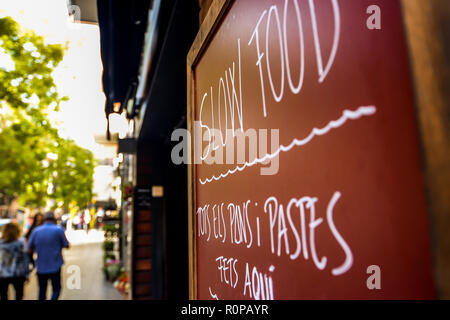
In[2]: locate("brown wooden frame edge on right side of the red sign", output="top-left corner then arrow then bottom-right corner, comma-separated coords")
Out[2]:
401,0 -> 450,299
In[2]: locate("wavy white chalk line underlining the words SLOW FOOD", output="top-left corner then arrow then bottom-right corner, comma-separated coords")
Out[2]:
199,106 -> 377,184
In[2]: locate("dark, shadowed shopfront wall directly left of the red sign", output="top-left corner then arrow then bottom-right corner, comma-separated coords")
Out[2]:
134,0 -> 199,300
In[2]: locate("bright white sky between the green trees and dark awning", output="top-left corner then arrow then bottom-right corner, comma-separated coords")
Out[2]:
0,0 -> 106,158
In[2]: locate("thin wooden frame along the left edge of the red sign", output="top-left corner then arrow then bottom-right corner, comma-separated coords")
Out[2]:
187,0 -> 233,299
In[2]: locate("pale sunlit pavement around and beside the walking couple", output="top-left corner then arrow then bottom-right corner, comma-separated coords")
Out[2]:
22,230 -> 122,300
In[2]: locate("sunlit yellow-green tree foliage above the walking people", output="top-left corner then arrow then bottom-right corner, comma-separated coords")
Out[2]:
0,17 -> 94,212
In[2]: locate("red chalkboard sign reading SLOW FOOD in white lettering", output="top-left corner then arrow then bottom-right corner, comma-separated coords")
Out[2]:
188,0 -> 434,299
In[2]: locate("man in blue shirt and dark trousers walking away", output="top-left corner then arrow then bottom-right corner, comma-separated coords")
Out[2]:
28,212 -> 69,300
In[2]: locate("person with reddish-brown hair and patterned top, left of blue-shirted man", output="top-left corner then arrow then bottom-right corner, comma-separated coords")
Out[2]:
0,223 -> 29,300
